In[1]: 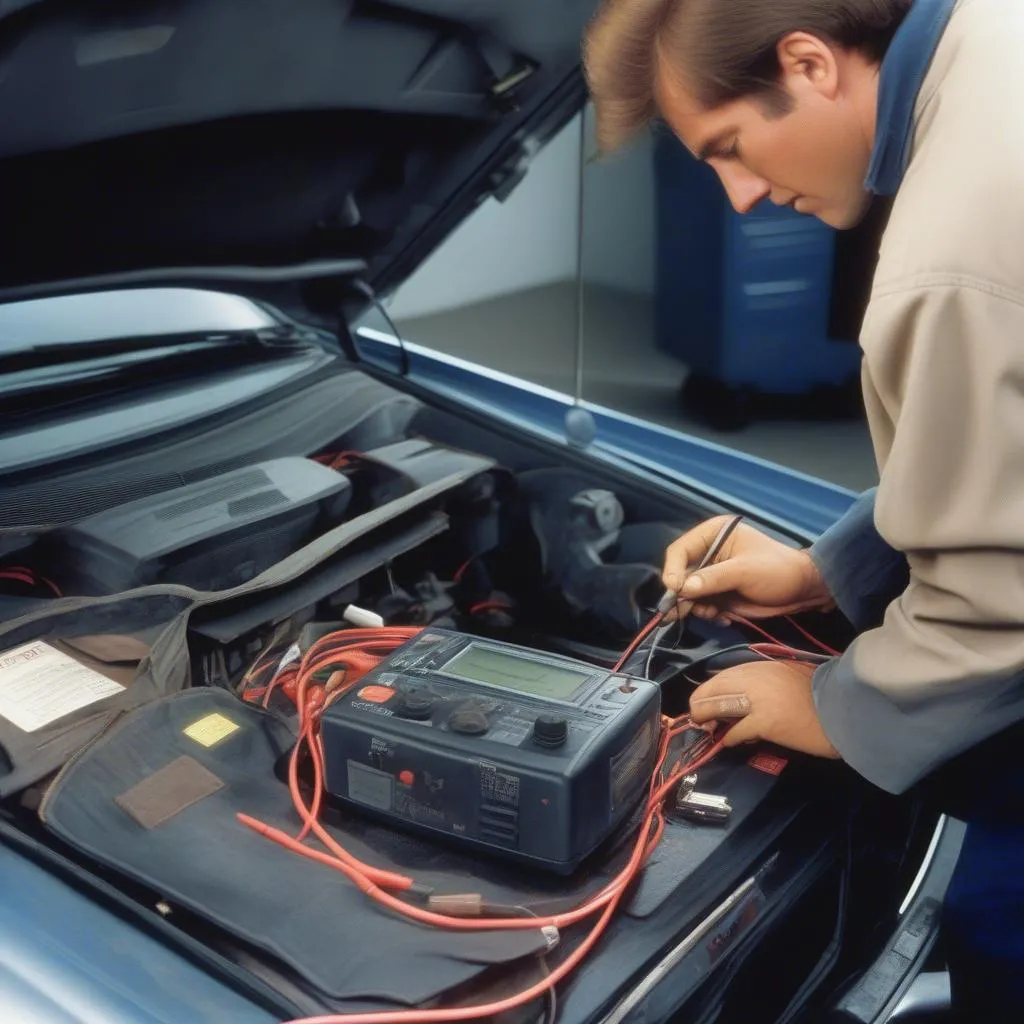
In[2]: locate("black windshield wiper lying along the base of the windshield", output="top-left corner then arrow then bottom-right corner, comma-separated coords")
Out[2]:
0,326 -> 315,376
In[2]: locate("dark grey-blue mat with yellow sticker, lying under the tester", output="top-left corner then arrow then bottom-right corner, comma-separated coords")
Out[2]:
29,687 -> 771,1012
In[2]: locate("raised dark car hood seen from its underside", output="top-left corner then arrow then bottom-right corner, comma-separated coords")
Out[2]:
0,0 -> 595,313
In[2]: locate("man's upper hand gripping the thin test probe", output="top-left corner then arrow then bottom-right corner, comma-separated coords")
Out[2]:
662,516 -> 835,620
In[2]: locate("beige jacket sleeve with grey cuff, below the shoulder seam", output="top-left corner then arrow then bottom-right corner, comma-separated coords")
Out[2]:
814,280 -> 1024,793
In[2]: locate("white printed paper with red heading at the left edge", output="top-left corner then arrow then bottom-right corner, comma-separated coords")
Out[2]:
0,640 -> 124,732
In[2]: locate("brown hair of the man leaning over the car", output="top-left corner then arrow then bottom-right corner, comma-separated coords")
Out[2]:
584,0 -> 912,152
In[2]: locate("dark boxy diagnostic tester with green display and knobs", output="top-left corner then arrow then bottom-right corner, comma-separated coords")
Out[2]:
321,629 -> 660,873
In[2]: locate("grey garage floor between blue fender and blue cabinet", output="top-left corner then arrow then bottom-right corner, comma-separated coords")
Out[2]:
398,283 -> 877,490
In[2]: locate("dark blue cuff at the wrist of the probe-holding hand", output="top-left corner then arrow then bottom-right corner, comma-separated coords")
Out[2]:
810,487 -> 908,630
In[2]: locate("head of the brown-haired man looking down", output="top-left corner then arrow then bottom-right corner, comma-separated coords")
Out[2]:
584,0 -> 912,227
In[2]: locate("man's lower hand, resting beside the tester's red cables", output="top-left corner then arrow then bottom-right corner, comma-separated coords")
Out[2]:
690,662 -> 839,758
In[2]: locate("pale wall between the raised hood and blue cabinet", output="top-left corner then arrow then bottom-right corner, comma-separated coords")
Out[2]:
389,103 -> 654,319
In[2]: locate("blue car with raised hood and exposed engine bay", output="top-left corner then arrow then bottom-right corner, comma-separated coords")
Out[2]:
0,0 -> 963,1024
